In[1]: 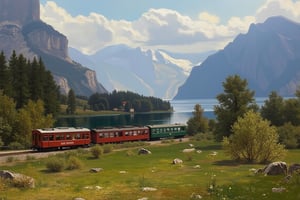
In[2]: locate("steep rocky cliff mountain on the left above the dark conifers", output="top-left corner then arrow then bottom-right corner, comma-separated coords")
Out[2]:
0,0 -> 107,96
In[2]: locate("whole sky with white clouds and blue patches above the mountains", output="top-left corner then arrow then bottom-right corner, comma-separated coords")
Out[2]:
40,0 -> 300,54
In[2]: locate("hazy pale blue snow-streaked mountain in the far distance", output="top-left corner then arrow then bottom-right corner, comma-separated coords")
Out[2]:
69,45 -> 201,99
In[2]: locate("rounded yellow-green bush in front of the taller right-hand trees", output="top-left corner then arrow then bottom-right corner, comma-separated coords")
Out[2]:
223,110 -> 285,163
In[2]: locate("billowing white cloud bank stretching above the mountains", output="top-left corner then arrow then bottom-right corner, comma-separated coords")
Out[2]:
41,0 -> 300,54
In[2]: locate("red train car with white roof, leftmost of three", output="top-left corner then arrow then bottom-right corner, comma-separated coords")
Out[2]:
32,127 -> 91,150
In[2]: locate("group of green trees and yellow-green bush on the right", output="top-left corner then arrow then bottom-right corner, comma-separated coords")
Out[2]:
187,75 -> 300,162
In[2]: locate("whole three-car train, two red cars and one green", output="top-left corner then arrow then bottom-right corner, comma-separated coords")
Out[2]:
32,123 -> 186,151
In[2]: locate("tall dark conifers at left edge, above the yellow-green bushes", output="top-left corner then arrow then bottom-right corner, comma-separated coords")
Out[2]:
0,51 -> 60,116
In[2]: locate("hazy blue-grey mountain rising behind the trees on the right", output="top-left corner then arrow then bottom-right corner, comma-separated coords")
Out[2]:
174,16 -> 300,99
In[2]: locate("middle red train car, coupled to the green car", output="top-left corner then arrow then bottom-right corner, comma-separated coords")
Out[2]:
91,126 -> 150,144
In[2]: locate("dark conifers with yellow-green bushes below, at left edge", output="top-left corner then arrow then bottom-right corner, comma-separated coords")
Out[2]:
0,51 -> 60,149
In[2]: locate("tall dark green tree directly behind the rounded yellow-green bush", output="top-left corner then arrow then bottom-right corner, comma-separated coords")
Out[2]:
214,75 -> 258,140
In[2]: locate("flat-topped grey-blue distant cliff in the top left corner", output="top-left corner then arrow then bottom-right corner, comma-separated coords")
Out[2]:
0,0 -> 40,25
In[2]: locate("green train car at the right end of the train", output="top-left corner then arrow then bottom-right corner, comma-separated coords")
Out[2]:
147,124 -> 186,140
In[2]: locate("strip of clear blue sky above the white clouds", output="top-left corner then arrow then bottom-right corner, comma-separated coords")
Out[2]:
41,0 -> 265,20
